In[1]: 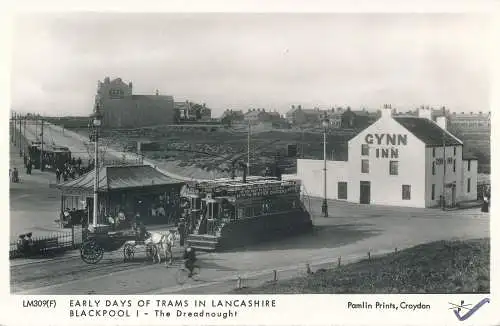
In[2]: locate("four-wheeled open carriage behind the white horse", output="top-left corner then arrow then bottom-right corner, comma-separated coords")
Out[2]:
80,229 -> 156,264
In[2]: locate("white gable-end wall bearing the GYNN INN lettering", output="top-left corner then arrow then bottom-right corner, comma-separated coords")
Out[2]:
348,114 -> 425,207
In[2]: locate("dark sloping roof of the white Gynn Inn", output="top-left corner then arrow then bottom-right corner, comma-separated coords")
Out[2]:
393,116 -> 463,146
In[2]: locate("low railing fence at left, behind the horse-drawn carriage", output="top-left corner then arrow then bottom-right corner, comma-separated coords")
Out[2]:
9,225 -> 84,259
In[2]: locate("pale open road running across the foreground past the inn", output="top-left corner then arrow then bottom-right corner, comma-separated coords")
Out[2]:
10,200 -> 489,294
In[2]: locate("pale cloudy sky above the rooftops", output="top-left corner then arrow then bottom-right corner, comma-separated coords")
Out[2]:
11,13 -> 491,116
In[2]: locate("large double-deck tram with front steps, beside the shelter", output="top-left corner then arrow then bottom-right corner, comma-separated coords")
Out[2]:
185,175 -> 312,251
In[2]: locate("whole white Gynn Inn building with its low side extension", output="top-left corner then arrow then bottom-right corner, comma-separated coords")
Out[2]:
297,107 -> 477,207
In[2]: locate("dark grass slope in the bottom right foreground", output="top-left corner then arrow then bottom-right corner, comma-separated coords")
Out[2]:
233,239 -> 490,294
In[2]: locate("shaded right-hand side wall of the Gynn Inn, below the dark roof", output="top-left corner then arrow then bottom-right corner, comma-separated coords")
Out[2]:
425,146 -> 464,207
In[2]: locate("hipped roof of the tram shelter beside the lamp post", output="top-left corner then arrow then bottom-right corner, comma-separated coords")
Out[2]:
58,165 -> 183,191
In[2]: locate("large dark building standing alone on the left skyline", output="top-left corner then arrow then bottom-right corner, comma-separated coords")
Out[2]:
95,77 -> 176,128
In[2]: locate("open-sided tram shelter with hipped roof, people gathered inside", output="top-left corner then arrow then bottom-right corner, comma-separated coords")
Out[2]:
56,165 -> 184,226
